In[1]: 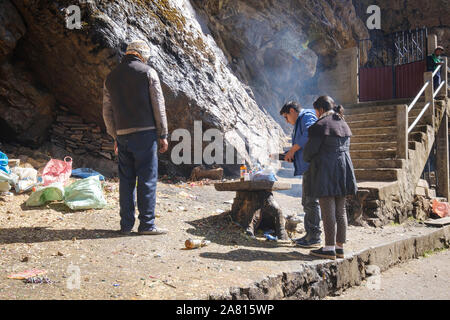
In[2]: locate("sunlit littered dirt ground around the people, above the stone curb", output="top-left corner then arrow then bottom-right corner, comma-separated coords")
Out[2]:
0,170 -> 440,300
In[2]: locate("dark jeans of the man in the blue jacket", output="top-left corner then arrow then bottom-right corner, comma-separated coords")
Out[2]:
302,171 -> 322,240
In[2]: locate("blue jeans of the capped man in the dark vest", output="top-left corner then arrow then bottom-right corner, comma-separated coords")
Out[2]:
117,130 -> 158,232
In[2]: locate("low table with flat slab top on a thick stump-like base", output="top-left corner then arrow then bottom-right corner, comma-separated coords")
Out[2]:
214,181 -> 292,240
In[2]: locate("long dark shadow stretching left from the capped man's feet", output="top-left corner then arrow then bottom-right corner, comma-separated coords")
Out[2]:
0,227 -> 123,244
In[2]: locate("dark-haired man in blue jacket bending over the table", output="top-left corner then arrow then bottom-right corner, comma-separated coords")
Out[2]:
280,101 -> 321,248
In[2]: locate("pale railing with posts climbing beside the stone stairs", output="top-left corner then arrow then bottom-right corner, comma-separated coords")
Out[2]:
397,58 -> 450,159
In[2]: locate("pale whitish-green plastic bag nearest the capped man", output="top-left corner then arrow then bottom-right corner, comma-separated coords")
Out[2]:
64,176 -> 106,210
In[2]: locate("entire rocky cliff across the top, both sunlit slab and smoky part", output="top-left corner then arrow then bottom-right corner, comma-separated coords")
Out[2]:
0,0 -> 450,175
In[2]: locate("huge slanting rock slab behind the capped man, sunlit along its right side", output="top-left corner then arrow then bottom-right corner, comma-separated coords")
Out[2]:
0,0 -> 283,175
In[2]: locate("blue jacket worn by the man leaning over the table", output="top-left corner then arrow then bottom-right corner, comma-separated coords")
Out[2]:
292,109 -> 317,176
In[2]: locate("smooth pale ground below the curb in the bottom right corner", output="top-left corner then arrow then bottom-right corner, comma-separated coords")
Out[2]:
327,249 -> 450,300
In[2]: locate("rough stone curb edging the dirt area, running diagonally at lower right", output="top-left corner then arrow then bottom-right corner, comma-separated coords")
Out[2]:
209,225 -> 450,300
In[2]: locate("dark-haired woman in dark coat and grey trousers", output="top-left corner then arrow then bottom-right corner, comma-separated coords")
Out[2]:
303,96 -> 357,260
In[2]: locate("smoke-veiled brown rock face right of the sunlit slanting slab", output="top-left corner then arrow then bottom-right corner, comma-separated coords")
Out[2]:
193,0 -> 368,129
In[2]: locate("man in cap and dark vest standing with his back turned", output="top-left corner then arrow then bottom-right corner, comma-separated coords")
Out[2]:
103,40 -> 168,235
